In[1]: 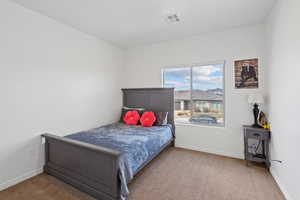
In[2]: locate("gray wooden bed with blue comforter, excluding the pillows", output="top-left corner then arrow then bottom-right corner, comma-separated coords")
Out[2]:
43,88 -> 175,200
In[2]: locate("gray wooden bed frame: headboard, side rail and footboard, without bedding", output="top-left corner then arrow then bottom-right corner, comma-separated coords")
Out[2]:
42,88 -> 175,200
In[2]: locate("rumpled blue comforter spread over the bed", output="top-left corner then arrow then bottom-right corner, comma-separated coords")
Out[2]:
66,123 -> 173,196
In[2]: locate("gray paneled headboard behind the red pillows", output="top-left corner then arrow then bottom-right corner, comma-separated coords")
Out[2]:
122,88 -> 175,133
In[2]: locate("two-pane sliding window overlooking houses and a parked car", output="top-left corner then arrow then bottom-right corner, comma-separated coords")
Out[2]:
163,62 -> 224,126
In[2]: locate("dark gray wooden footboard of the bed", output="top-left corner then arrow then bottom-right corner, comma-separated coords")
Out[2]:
42,134 -> 120,200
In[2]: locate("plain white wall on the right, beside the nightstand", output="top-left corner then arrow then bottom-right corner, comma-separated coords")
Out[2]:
267,0 -> 300,200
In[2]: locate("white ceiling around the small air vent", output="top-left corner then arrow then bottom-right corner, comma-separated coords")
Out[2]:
13,0 -> 276,48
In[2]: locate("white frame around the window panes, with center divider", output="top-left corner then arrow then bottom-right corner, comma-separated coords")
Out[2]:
161,60 -> 227,128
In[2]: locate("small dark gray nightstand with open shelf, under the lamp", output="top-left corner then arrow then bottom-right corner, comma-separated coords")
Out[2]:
243,125 -> 271,169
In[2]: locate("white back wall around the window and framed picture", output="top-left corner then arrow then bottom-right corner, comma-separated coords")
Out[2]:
123,25 -> 265,158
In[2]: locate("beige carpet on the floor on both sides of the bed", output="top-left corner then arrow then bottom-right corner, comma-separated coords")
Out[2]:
0,148 -> 284,200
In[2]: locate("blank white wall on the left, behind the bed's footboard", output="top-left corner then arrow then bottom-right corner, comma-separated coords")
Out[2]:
0,0 -> 123,190
